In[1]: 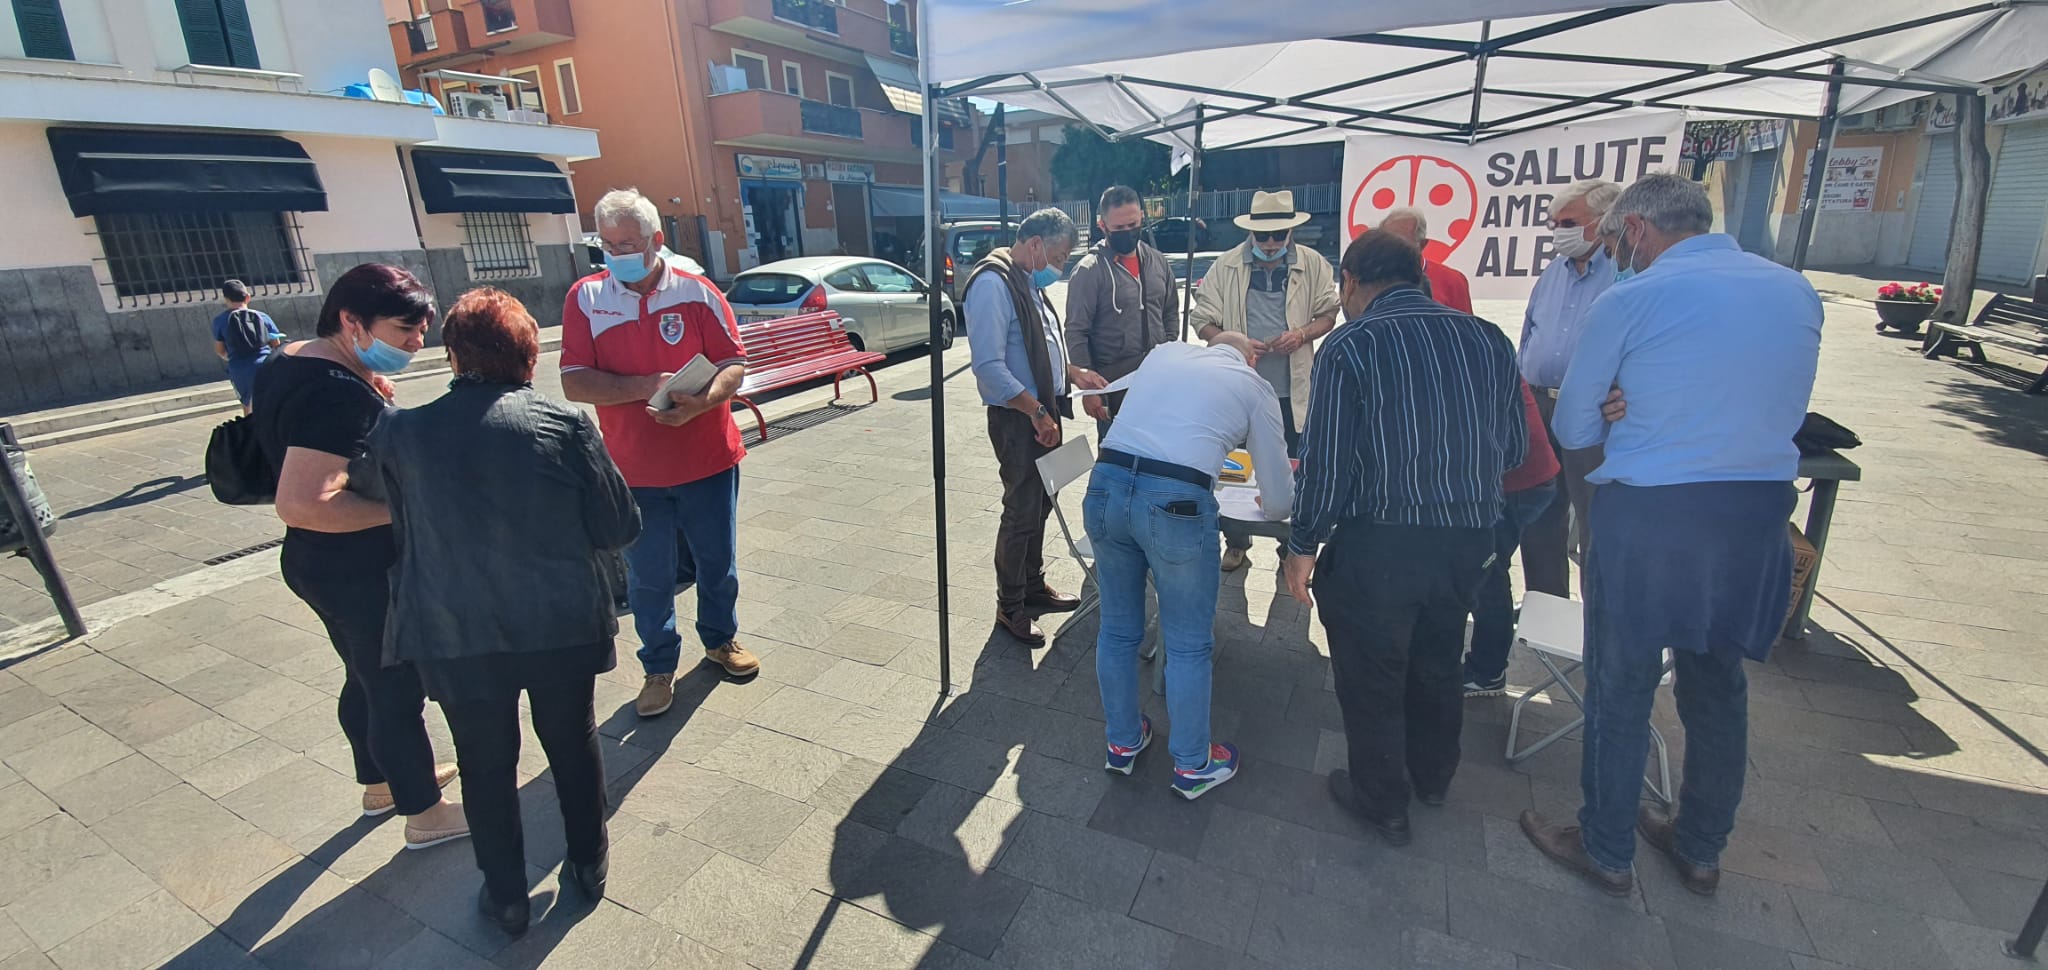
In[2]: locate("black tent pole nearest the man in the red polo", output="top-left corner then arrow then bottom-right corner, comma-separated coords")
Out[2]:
918,39 -> 954,687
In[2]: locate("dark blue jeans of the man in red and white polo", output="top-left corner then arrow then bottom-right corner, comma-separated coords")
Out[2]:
627,465 -> 739,673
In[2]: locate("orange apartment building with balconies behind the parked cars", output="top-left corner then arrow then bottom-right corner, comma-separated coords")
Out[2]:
385,0 -> 977,278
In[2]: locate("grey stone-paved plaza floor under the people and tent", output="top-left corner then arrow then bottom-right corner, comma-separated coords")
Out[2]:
0,290 -> 2048,970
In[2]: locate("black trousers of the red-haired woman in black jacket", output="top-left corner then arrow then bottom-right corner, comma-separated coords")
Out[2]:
440,657 -> 608,902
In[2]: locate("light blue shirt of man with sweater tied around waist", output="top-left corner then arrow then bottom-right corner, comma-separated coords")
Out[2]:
1550,233 -> 1821,485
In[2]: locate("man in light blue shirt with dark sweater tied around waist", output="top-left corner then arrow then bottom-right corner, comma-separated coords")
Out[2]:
1522,174 -> 1821,896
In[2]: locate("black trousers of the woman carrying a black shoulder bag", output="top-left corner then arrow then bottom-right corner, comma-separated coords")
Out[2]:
283,546 -> 440,814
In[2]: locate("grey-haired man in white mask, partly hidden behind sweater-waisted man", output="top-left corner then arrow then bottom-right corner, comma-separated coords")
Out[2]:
1518,178 -> 1622,596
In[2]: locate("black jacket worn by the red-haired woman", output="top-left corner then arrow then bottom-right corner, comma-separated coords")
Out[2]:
350,381 -> 641,663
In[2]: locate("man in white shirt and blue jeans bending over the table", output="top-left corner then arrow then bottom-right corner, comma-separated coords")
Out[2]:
1081,334 -> 1294,798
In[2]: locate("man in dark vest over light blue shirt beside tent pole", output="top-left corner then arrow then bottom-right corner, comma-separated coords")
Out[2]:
961,209 -> 1102,647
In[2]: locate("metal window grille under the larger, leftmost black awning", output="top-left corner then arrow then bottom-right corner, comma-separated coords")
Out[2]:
92,213 -> 315,307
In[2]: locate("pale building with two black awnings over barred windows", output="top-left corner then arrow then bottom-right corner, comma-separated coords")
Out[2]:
0,0 -> 598,413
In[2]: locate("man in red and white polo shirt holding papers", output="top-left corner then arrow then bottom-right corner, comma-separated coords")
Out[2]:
561,188 -> 760,718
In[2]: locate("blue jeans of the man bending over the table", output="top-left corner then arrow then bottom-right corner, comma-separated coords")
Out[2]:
1081,465 -> 1221,769
